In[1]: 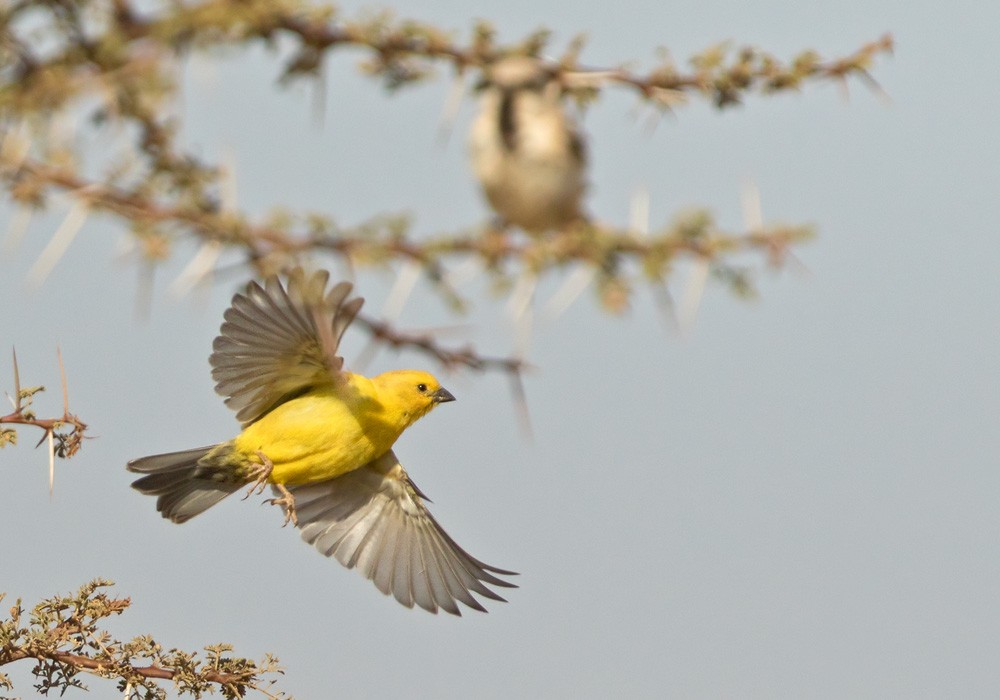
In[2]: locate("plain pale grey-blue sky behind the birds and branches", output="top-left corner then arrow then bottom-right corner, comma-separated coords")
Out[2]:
0,0 -> 1000,698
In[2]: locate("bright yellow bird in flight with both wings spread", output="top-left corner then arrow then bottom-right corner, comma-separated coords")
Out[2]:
128,270 -> 516,615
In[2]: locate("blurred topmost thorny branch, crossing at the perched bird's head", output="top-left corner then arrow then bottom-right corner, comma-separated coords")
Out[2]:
0,0 -> 893,107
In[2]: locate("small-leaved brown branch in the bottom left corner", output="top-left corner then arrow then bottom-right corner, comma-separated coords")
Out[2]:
0,579 -> 287,700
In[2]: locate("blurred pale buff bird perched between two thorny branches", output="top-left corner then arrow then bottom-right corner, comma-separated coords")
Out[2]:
469,56 -> 586,234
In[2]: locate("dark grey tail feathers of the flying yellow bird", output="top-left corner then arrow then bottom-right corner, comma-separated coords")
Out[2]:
128,445 -> 244,523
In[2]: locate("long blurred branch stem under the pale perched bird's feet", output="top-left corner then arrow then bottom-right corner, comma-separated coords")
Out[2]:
0,154 -> 812,271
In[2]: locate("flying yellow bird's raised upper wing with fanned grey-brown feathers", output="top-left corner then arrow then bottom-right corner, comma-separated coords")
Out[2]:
209,269 -> 364,426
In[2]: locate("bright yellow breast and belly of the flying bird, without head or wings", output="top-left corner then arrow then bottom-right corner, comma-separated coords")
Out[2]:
233,375 -> 406,484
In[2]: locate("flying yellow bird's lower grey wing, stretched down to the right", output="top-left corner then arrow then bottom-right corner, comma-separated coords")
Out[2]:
287,451 -> 517,615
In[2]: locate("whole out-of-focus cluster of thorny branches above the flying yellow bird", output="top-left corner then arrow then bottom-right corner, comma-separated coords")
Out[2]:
0,0 -> 892,368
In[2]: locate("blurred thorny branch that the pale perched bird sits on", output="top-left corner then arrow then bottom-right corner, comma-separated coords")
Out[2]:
0,152 -> 813,306
